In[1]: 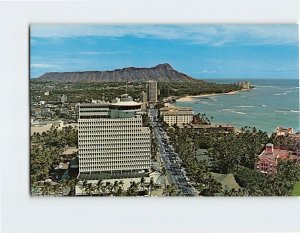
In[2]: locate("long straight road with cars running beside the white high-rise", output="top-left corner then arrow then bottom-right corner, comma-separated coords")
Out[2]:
149,108 -> 195,196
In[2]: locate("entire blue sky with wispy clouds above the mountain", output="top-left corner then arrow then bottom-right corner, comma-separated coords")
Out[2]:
30,24 -> 299,79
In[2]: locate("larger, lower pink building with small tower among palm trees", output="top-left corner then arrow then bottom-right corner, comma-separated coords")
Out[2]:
255,143 -> 294,175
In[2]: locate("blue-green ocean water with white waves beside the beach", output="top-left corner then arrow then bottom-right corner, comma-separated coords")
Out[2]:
176,79 -> 300,134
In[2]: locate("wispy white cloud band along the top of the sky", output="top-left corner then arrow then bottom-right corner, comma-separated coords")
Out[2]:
31,24 -> 298,46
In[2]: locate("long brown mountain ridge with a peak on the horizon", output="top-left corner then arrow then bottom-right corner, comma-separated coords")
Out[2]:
34,63 -> 199,82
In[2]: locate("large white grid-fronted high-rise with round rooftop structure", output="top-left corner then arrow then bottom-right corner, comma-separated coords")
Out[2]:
78,94 -> 151,178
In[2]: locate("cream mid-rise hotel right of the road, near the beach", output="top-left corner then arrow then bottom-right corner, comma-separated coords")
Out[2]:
160,105 -> 194,126
